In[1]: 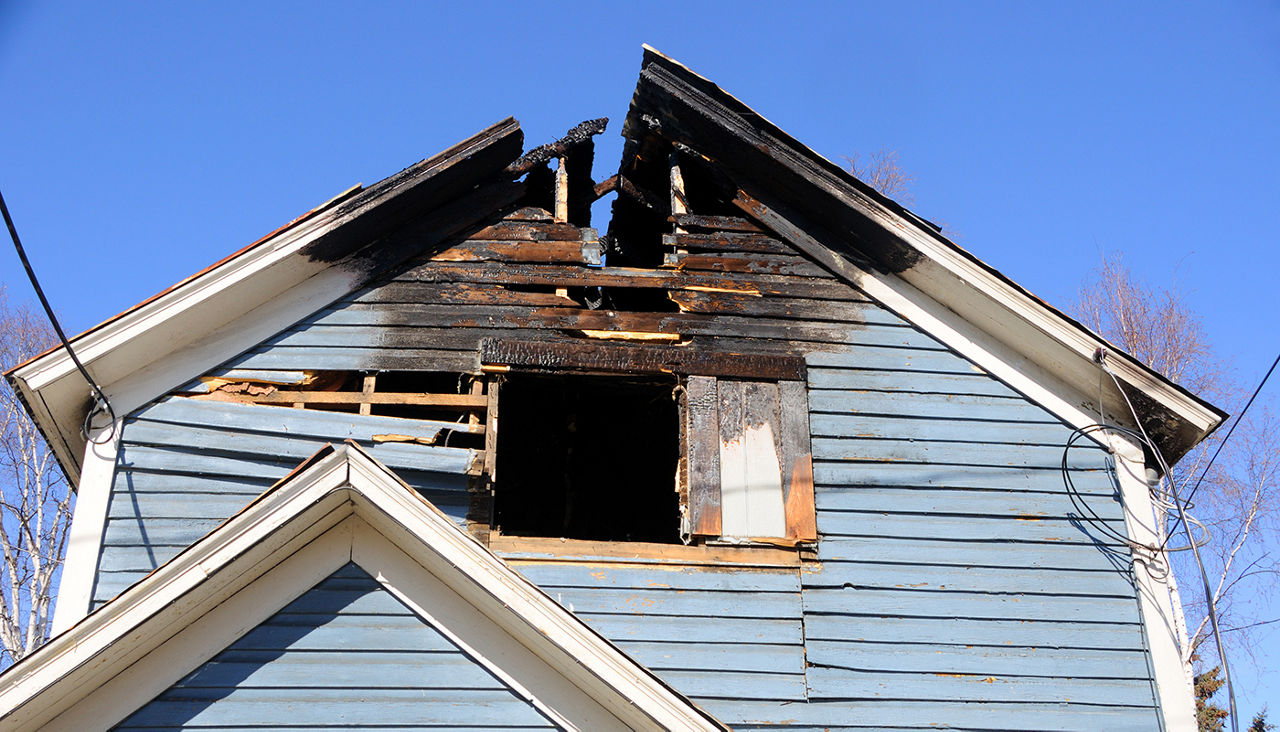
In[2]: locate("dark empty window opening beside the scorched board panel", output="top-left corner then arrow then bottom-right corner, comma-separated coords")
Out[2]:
494,374 -> 680,544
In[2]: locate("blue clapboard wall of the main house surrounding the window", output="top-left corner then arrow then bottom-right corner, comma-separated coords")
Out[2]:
82,208 -> 1160,729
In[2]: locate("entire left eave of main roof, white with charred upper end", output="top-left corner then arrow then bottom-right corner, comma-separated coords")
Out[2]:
8,118 -> 522,484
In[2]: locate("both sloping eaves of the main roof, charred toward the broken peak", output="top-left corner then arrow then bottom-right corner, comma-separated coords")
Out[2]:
10,47 -> 1225,480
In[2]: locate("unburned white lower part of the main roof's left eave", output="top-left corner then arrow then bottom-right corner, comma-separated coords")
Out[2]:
13,210 -> 357,482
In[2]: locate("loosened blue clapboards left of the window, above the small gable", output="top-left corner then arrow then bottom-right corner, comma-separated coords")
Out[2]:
93,397 -> 475,605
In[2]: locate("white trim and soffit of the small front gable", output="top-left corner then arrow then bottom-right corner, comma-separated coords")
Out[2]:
0,444 -> 727,731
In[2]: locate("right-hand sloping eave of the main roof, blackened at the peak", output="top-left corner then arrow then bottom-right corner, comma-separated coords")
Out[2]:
620,46 -> 1226,462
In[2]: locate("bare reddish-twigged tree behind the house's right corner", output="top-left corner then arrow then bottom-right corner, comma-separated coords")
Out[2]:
1075,256 -> 1280,668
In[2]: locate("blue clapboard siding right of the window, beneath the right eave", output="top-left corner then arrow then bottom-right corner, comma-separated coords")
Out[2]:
798,347 -> 1158,729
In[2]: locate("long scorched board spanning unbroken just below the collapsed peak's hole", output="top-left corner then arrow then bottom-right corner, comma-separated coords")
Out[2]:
398,262 -> 855,299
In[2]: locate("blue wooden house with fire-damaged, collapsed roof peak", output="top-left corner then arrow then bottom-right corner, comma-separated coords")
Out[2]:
0,49 -> 1224,731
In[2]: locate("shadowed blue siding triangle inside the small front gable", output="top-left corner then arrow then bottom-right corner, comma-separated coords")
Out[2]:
116,564 -> 554,731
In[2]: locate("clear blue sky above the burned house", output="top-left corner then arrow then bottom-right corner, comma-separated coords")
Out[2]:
0,0 -> 1280,714
